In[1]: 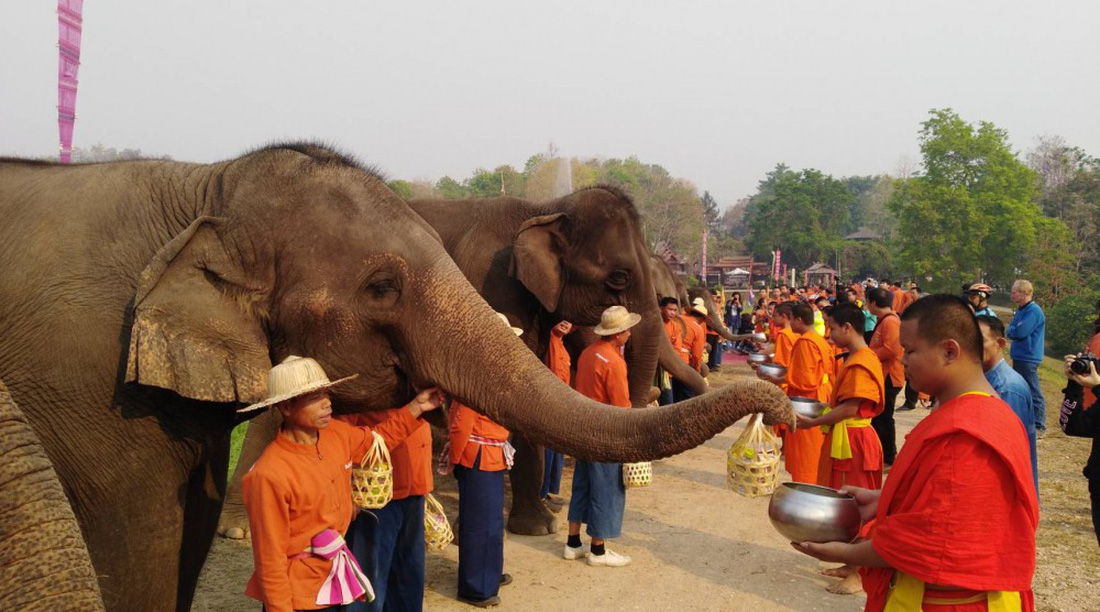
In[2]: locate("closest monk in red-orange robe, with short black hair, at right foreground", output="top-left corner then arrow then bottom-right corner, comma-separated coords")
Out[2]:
793,295 -> 1038,612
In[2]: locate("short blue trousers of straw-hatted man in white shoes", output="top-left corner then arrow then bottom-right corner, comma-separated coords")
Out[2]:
569,459 -> 626,539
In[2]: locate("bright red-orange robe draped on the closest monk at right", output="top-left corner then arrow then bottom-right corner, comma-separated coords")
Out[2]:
859,394 -> 1038,612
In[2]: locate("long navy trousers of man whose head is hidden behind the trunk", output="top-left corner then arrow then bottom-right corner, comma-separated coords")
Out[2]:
454,453 -> 504,600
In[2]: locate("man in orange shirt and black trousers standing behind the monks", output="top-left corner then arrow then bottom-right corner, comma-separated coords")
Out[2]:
867,287 -> 905,466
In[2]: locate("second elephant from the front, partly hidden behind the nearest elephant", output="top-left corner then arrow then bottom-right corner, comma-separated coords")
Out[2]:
219,186 -> 705,537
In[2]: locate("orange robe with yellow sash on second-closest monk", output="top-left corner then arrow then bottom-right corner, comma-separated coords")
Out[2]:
817,347 -> 886,489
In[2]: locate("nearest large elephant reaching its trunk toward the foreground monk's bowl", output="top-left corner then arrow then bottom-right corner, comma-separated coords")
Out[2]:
0,143 -> 793,611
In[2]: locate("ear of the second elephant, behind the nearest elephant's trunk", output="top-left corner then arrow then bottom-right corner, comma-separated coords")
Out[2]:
512,212 -> 569,313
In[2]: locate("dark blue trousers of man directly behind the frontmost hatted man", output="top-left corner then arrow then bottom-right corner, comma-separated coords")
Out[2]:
345,495 -> 425,612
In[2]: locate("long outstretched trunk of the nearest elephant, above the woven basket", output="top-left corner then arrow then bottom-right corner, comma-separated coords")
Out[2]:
403,261 -> 794,461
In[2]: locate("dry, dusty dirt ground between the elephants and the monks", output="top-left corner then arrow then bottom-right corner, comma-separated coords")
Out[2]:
194,356 -> 1100,612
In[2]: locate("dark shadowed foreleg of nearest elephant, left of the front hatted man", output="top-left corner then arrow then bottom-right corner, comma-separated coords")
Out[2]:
176,431 -> 229,612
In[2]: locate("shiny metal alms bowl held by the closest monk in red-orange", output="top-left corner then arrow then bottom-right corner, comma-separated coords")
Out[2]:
768,482 -> 862,542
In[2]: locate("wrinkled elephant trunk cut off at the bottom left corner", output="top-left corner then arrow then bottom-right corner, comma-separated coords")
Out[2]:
0,384 -> 103,611
